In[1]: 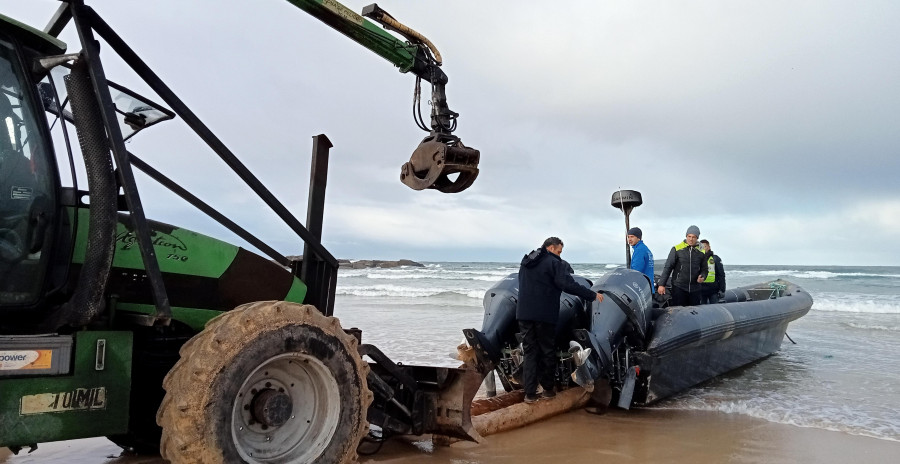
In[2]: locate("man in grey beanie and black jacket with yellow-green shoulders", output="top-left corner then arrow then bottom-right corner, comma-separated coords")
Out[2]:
657,226 -> 709,306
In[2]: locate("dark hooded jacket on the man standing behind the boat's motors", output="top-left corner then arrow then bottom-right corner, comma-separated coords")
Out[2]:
516,248 -> 597,324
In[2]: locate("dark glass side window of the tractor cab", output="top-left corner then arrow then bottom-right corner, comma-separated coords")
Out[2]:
0,38 -> 55,305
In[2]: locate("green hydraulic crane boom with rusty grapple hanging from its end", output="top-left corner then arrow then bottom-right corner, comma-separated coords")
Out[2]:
288,0 -> 481,193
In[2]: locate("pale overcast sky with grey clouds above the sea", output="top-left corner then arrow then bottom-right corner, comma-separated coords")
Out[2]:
7,0 -> 900,265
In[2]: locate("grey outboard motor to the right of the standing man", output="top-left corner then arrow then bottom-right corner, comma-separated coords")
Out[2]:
569,268 -> 653,391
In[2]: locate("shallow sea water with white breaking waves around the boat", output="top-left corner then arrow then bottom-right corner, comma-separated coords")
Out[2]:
335,262 -> 900,441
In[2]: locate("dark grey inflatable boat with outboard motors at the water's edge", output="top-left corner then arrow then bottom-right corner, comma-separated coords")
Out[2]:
463,268 -> 813,409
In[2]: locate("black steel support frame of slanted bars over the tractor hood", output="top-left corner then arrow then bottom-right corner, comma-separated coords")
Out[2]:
61,0 -> 338,321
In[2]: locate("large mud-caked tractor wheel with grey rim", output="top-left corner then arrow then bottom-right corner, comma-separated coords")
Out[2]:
156,301 -> 372,464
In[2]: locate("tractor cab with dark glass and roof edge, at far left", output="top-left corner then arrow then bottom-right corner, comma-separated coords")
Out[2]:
0,16 -> 64,314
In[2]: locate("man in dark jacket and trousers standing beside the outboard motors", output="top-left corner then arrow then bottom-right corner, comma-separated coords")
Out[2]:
516,237 -> 603,403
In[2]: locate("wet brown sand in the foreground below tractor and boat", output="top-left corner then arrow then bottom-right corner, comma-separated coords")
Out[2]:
0,409 -> 900,464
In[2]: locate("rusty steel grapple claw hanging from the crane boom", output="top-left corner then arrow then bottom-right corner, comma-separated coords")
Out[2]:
400,132 -> 481,193
